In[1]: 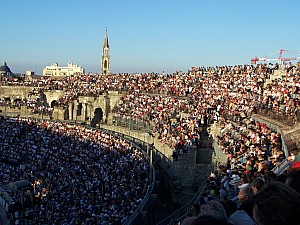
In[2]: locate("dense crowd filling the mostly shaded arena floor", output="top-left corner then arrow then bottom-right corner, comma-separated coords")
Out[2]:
0,117 -> 150,224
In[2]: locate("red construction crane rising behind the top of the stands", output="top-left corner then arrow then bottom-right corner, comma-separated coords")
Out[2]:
251,49 -> 300,65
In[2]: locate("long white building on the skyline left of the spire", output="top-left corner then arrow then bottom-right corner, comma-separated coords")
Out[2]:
43,63 -> 84,76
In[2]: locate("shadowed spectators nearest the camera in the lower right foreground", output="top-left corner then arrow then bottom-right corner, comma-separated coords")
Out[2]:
180,162 -> 300,225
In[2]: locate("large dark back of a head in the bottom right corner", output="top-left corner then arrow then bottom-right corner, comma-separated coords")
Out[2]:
252,181 -> 300,225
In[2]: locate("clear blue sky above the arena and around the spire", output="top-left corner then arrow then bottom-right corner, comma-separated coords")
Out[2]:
0,0 -> 300,74
